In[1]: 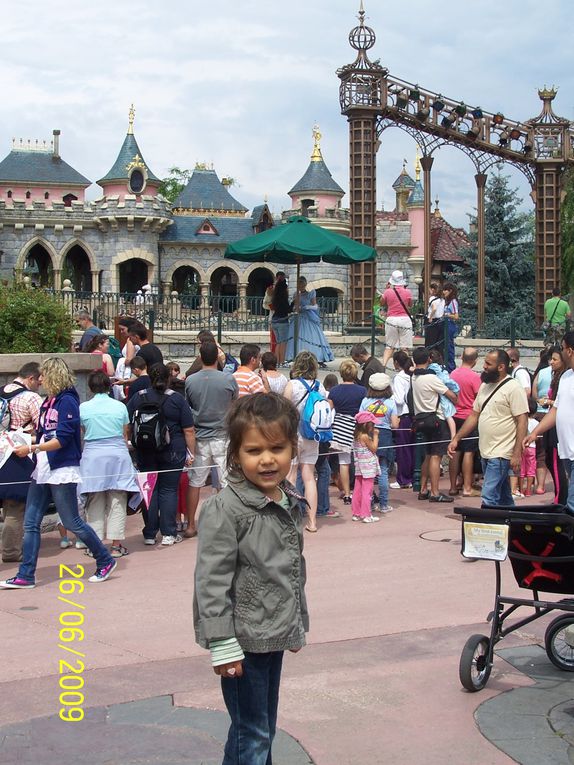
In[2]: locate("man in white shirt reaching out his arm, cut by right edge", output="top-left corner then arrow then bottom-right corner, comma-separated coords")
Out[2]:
524,332 -> 574,513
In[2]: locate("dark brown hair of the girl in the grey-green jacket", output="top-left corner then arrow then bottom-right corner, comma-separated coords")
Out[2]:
227,393 -> 299,475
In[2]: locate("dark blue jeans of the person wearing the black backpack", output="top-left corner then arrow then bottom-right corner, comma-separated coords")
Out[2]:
137,451 -> 185,539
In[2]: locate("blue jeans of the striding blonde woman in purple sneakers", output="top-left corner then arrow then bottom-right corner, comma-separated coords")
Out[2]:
18,481 -> 113,583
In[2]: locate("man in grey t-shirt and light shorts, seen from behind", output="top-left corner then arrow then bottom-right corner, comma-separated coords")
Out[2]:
184,341 -> 238,537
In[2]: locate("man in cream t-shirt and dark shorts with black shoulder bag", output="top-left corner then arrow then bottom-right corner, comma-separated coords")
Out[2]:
412,348 -> 457,502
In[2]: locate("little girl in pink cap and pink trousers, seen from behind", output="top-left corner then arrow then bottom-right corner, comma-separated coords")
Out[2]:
351,412 -> 380,523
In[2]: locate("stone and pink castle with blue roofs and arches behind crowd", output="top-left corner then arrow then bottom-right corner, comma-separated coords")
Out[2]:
0,107 -> 467,314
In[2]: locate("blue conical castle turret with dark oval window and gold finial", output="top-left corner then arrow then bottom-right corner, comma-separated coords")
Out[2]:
98,104 -> 161,199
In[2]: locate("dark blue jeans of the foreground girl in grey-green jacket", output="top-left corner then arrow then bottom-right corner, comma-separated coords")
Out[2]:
221,651 -> 283,765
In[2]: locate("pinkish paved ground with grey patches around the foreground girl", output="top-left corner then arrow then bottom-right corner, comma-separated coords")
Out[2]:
0,480 -> 574,765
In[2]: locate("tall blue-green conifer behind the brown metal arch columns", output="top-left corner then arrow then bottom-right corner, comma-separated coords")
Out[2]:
454,172 -> 536,337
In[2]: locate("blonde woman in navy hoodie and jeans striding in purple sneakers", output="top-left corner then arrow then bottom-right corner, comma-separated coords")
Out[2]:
0,357 -> 117,590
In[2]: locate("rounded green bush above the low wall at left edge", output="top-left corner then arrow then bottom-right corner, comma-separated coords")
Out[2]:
0,285 -> 73,353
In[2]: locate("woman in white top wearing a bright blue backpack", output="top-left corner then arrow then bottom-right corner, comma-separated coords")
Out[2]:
283,351 -> 334,534
